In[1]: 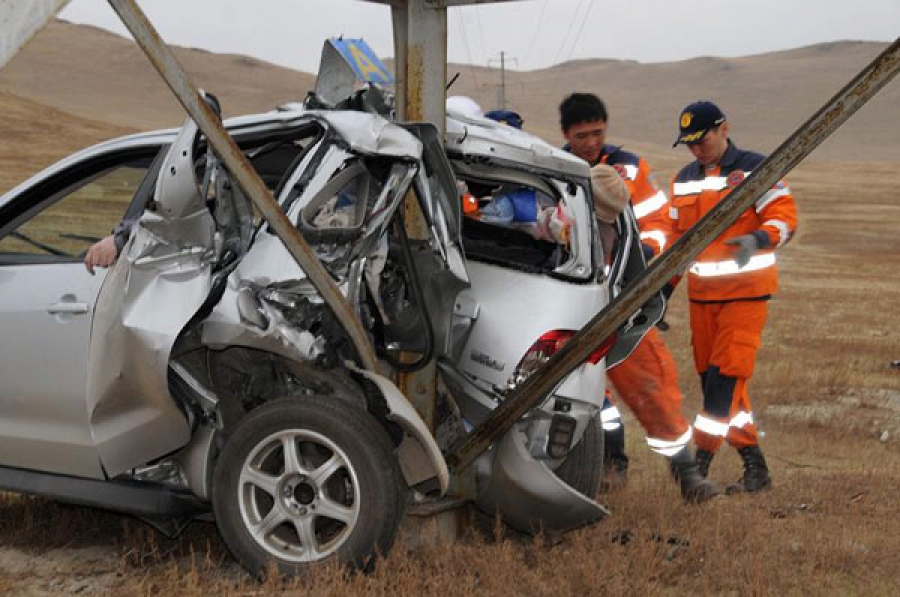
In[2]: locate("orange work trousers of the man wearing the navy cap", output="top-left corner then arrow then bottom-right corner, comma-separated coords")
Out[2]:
690,300 -> 769,453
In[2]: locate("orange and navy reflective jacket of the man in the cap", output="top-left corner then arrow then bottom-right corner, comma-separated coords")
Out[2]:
665,140 -> 797,302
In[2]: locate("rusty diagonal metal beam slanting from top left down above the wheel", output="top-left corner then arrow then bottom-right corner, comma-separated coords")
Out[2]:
109,0 -> 377,371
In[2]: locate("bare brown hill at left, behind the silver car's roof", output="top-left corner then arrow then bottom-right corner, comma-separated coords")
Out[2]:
0,21 -> 315,129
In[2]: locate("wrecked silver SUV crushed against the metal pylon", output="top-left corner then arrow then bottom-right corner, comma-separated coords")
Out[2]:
0,94 -> 654,572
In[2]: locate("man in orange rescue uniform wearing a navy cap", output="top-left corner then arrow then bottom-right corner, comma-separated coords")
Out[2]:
667,101 -> 797,493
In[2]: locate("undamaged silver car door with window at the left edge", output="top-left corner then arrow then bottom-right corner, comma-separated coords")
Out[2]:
0,139 -> 161,478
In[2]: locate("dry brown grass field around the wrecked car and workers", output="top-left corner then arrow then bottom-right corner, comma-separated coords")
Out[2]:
0,19 -> 900,596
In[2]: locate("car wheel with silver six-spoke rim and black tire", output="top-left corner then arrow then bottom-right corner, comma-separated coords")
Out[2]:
212,396 -> 408,576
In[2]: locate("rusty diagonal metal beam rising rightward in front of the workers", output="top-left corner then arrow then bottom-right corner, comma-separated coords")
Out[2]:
447,38 -> 900,471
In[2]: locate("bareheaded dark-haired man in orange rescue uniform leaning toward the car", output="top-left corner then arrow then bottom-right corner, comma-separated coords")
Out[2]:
559,93 -> 718,501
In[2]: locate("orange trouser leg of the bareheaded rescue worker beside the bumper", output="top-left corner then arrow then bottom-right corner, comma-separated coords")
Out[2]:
606,327 -> 689,441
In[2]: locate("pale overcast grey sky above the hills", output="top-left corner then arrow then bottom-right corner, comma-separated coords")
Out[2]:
60,0 -> 900,72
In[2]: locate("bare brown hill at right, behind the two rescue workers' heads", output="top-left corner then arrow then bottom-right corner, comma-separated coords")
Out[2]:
453,42 -> 900,161
